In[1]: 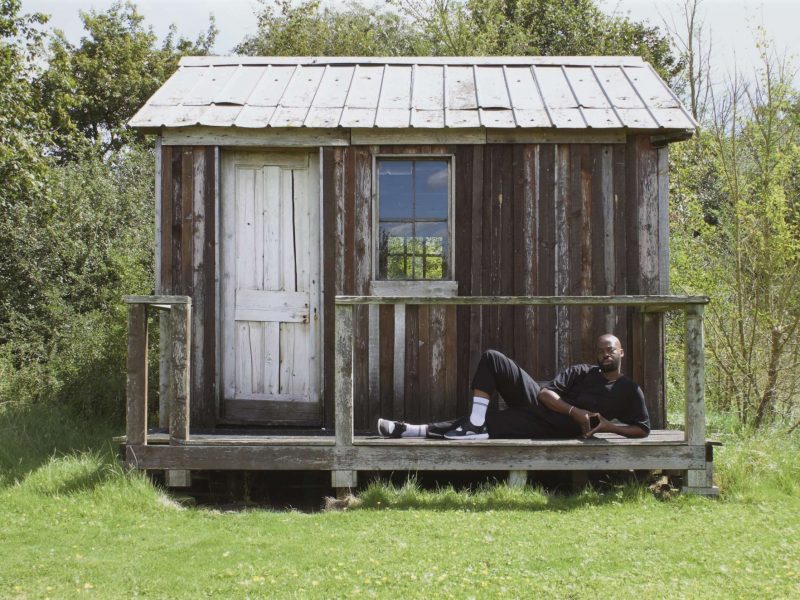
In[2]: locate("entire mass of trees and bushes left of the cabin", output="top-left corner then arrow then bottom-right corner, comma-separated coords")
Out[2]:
0,0 -> 215,420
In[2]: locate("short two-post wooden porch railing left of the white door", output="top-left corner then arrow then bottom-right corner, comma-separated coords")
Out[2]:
122,296 -> 192,445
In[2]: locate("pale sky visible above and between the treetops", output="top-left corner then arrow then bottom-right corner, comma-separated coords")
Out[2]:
17,0 -> 800,83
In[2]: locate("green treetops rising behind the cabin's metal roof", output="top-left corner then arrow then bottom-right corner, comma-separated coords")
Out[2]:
236,0 -> 682,80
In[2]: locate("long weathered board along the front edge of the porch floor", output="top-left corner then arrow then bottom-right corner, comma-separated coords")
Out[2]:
126,442 -> 706,471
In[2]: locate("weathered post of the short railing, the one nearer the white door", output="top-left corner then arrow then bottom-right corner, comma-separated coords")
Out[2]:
169,301 -> 192,445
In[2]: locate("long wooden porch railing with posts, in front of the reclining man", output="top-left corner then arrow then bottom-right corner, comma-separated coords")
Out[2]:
334,296 -> 709,487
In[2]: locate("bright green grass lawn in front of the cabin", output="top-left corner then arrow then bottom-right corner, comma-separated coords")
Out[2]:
0,406 -> 800,598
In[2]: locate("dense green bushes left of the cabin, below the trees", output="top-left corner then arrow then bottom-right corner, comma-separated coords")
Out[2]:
0,148 -> 154,417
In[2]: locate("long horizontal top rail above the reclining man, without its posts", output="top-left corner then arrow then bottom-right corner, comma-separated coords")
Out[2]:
336,296 -> 709,311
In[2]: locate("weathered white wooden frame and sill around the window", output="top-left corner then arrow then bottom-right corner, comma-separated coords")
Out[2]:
372,152 -> 458,295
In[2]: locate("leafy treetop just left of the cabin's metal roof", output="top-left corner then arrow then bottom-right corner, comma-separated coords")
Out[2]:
36,1 -> 217,159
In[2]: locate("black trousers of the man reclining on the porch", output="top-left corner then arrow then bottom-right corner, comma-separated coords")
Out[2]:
428,350 -> 581,439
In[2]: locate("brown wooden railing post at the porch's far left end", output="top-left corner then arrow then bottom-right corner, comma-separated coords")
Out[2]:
125,304 -> 147,445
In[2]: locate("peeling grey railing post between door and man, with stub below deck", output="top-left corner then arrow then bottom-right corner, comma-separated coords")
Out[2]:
331,305 -> 357,495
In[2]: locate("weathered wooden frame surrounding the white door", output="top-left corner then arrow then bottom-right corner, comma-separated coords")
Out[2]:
216,147 -> 325,428
